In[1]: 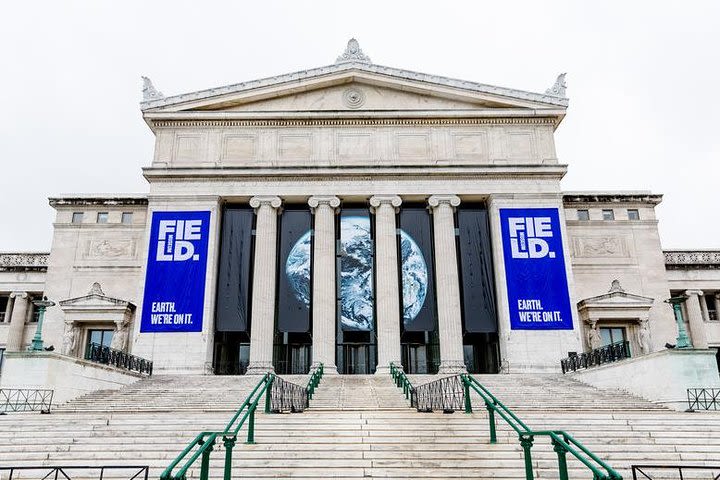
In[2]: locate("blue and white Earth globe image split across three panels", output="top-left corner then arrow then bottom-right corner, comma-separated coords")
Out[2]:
285,216 -> 428,331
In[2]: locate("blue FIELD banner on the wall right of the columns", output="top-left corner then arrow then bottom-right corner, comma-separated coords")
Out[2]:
500,208 -> 573,330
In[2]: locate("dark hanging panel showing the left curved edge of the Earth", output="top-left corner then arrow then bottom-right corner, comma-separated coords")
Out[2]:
277,208 -> 312,332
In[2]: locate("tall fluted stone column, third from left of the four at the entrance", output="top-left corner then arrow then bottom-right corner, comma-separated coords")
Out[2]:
370,195 -> 402,374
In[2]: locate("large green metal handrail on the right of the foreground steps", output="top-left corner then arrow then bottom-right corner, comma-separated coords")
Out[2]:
460,374 -> 622,480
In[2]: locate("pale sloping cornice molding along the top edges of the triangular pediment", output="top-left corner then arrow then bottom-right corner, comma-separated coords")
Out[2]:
140,54 -> 569,111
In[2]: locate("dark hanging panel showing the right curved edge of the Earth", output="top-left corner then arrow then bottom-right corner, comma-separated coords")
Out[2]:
400,207 -> 437,331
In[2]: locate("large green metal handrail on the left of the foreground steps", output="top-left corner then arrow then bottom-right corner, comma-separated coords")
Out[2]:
160,373 -> 275,480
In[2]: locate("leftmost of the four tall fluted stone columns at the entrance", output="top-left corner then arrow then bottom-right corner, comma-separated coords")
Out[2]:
247,197 -> 281,375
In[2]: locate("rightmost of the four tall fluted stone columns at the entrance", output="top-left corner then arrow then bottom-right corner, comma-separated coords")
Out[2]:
428,195 -> 466,375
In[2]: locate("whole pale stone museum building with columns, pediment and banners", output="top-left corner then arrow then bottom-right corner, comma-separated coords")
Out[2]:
0,40 -> 720,374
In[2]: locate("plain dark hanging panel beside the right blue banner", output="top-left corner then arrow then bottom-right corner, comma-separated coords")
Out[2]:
458,207 -> 497,333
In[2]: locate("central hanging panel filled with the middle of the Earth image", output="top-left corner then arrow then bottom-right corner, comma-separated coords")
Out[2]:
338,208 -> 375,331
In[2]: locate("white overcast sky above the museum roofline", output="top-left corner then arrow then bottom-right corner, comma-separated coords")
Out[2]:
0,0 -> 720,251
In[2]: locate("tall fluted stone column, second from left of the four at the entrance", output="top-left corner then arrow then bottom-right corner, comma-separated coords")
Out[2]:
308,196 -> 340,374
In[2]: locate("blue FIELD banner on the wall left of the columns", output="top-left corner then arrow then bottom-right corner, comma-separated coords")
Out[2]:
140,212 -> 210,333
